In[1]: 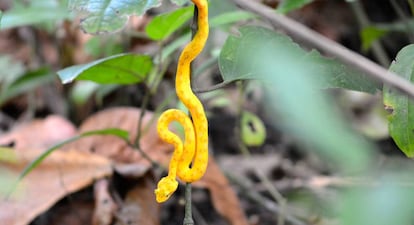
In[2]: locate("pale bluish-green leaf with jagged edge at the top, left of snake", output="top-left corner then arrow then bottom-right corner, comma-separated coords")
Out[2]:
69,0 -> 160,34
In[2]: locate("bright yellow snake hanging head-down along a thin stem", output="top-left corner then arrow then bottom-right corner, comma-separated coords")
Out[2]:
155,0 -> 209,202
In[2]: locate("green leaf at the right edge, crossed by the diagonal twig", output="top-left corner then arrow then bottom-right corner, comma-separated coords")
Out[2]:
383,45 -> 414,157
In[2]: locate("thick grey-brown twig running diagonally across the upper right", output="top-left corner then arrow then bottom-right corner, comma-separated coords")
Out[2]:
231,0 -> 414,98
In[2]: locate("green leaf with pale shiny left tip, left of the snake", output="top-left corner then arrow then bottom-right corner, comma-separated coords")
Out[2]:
57,54 -> 152,84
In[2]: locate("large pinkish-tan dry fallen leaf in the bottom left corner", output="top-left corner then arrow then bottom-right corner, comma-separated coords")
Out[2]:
0,149 -> 112,225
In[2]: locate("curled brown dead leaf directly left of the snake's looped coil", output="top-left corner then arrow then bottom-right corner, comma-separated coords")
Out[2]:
64,107 -> 173,166
